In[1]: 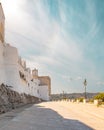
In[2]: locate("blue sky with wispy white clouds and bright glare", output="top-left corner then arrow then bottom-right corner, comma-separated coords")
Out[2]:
1,0 -> 104,93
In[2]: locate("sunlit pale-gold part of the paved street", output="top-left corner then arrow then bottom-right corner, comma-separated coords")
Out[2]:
45,101 -> 104,130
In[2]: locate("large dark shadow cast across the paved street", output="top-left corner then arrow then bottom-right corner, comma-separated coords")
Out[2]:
0,104 -> 93,130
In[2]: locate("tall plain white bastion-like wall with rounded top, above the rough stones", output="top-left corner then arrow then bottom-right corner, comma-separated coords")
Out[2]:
4,45 -> 21,92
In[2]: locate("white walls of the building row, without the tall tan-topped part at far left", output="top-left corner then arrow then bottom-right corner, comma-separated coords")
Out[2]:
0,43 -> 49,100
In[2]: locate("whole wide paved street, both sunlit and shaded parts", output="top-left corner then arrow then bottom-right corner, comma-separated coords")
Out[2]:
0,102 -> 104,130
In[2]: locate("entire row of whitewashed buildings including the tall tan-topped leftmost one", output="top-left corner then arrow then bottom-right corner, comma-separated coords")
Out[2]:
0,4 -> 50,100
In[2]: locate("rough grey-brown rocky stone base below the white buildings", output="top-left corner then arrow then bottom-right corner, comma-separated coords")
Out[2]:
0,84 -> 39,114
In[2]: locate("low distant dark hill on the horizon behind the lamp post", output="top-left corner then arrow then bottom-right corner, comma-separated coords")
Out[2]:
51,92 -> 98,100
